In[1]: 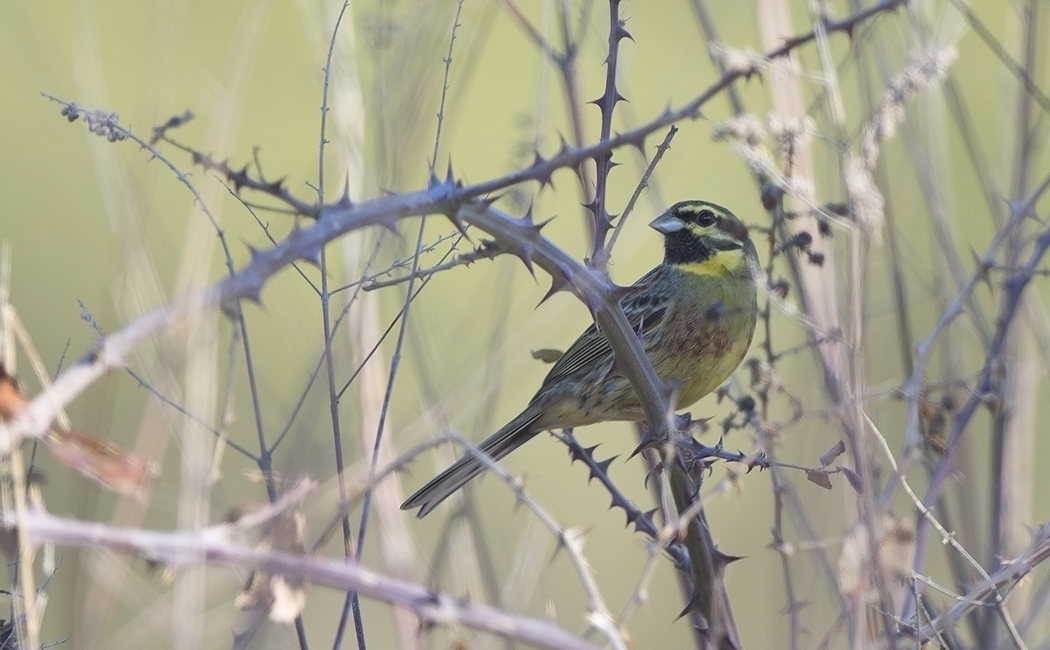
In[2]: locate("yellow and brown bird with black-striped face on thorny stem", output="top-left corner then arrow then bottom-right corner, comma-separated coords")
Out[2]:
401,200 -> 758,518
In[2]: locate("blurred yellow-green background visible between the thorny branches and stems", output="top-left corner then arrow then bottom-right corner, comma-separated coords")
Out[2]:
0,0 -> 1050,648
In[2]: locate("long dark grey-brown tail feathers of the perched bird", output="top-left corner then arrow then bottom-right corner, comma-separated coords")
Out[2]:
401,411 -> 543,519
